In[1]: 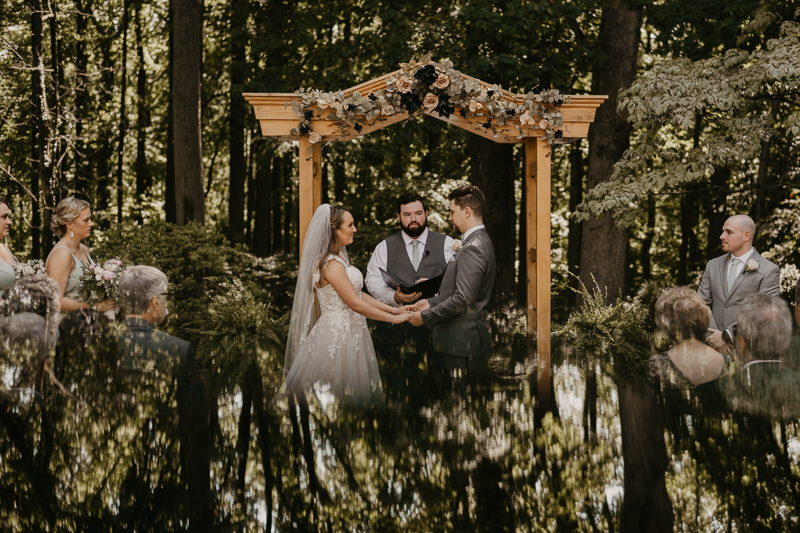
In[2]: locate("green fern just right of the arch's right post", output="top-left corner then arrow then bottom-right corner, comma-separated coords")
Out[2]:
553,277 -> 653,377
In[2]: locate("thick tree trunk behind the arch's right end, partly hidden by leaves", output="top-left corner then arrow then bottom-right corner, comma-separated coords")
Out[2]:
580,0 -> 642,300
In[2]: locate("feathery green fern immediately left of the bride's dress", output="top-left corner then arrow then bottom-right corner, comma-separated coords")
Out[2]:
189,278 -> 291,382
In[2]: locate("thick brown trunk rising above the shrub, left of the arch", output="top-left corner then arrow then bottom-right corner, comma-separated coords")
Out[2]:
172,0 -> 206,225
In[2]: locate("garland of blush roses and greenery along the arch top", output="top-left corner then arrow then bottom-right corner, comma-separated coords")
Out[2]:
287,54 -> 569,144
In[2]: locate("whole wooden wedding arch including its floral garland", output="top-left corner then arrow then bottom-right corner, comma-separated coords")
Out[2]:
244,55 -> 608,398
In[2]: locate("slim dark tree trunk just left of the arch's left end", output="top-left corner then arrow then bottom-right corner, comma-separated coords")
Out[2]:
228,2 -> 245,242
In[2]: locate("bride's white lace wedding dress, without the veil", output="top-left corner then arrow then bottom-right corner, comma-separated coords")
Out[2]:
279,255 -> 383,405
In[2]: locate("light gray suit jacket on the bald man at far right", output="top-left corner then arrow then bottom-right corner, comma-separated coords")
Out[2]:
697,250 -> 781,331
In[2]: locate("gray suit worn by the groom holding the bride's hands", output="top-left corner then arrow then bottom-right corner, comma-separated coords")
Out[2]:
422,229 -> 495,357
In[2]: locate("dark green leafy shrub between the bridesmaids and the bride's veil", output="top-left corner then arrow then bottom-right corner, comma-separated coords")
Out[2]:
94,221 -> 254,336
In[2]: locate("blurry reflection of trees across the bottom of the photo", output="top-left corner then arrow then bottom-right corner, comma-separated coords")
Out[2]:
0,302 -> 800,531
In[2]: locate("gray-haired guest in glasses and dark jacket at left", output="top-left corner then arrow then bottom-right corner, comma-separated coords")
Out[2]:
117,265 -> 192,369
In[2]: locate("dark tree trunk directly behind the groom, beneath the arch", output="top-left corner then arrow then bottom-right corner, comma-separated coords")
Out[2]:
467,135 -> 517,309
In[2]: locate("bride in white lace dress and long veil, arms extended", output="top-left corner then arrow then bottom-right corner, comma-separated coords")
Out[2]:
276,204 -> 413,405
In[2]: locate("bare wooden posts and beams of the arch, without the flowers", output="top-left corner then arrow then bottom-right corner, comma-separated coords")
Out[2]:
244,71 -> 608,390
